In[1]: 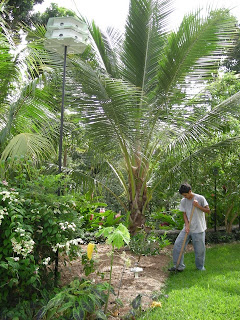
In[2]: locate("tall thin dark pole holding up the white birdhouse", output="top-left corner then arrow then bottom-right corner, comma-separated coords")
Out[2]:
54,46 -> 67,286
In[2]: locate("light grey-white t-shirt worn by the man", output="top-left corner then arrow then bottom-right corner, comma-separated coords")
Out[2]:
179,193 -> 208,233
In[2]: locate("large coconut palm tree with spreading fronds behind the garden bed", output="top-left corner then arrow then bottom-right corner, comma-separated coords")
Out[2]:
11,0 -> 239,232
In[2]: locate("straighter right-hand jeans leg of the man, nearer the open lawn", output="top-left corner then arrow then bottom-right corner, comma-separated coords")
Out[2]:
192,231 -> 206,270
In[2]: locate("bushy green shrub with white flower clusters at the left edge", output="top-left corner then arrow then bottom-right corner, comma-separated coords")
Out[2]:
0,178 -> 87,307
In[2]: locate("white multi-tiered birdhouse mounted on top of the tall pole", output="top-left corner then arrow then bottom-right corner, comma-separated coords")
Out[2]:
45,17 -> 88,53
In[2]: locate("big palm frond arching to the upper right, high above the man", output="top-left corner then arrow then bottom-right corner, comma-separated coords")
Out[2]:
158,10 -> 236,101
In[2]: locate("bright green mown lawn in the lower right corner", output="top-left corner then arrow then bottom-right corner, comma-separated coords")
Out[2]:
138,242 -> 240,320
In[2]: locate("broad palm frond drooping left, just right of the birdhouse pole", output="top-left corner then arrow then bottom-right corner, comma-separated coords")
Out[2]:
65,52 -> 142,150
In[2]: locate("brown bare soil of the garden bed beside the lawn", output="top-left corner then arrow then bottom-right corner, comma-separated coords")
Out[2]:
59,244 -> 172,319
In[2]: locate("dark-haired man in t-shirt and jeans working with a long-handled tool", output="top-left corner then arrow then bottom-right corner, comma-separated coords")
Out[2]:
168,183 -> 210,271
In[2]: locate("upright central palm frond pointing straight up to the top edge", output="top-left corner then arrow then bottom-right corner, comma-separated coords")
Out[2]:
122,0 -> 172,90
